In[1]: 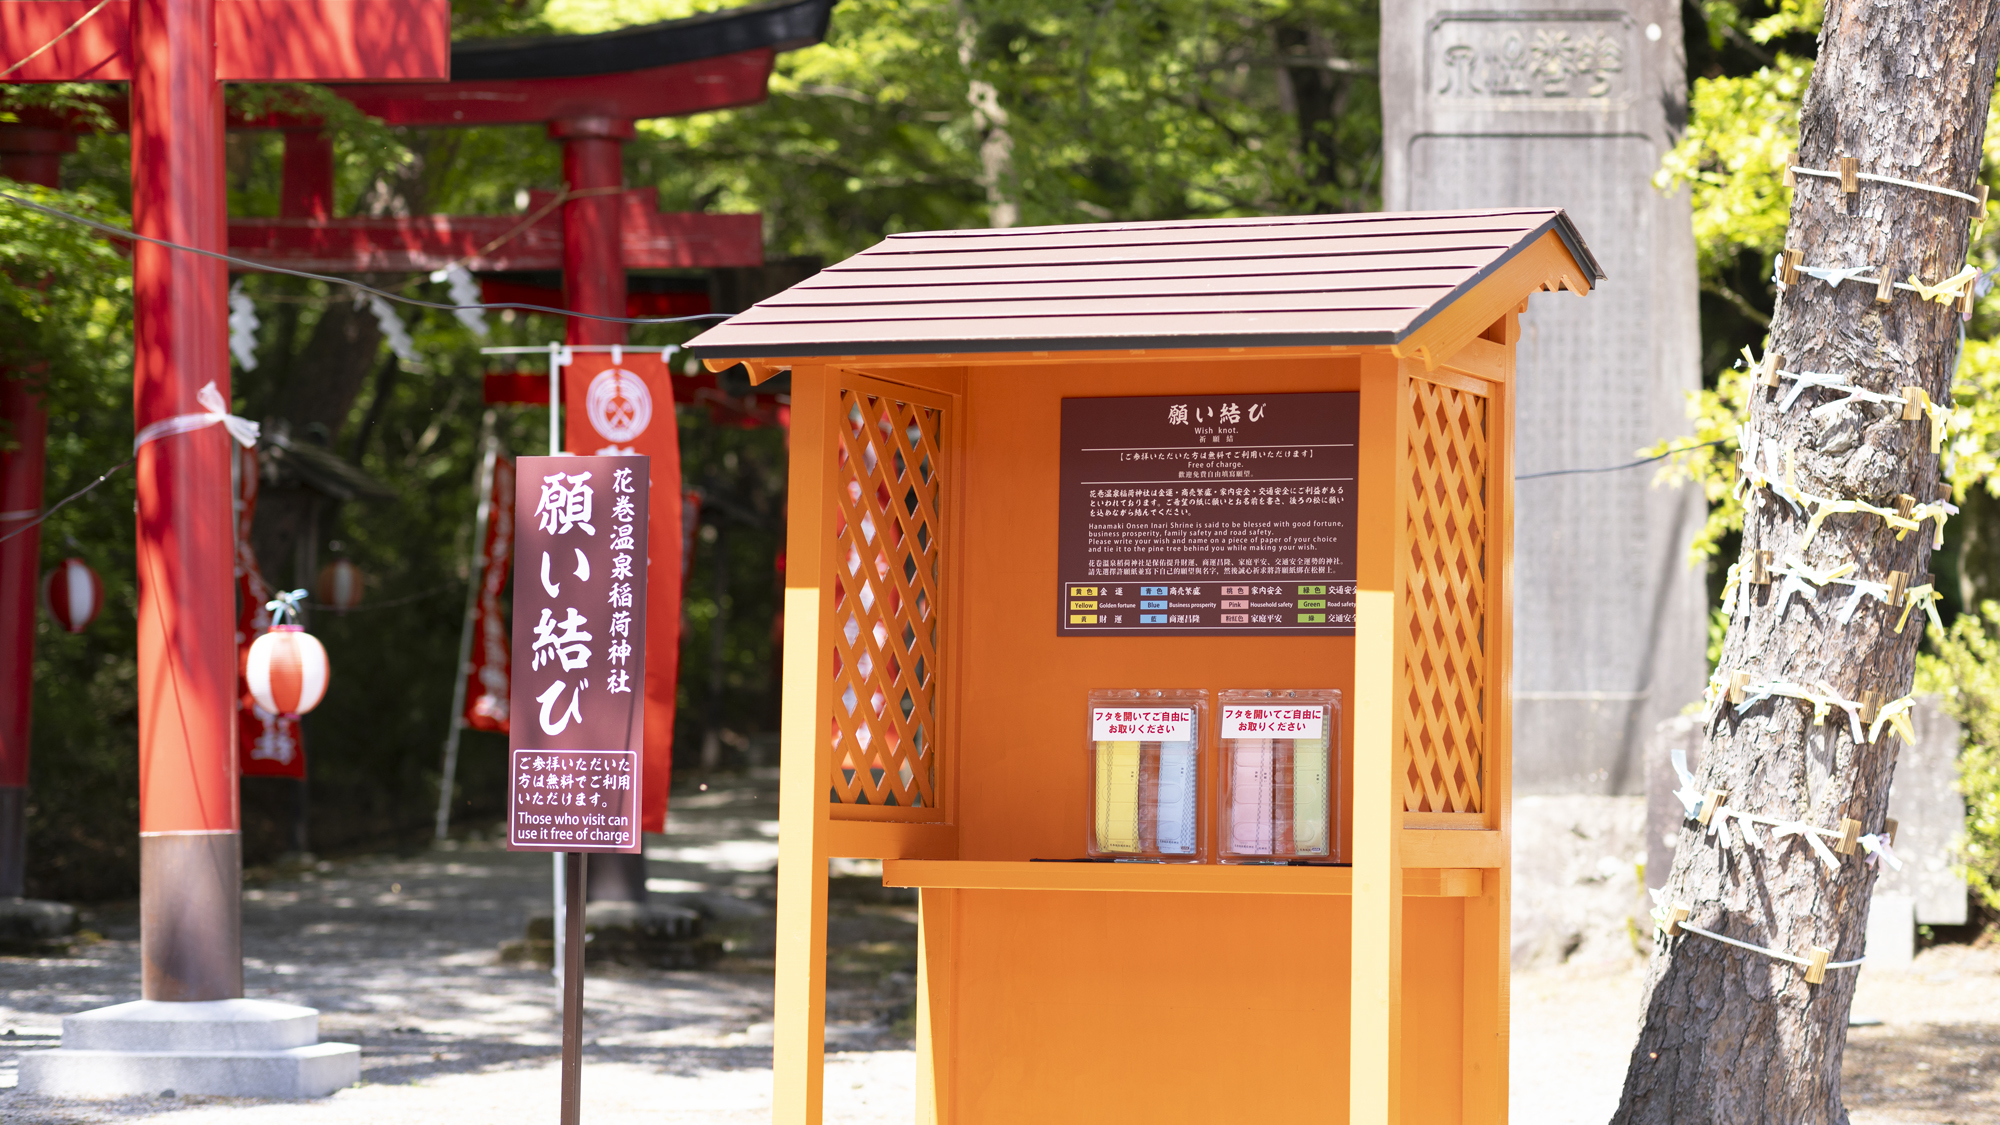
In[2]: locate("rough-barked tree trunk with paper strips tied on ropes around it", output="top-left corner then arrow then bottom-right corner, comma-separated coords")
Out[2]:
1614,0 -> 2000,1125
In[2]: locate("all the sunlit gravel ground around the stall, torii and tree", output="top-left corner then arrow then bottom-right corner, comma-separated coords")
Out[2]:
0,768 -> 2000,1125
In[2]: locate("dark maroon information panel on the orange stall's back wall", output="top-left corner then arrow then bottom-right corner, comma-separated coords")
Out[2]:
1056,392 -> 1360,637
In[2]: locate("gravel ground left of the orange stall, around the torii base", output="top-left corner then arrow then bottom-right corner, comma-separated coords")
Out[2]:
0,785 -> 916,1125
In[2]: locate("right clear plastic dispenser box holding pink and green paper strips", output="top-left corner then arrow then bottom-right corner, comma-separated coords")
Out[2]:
1216,691 -> 1346,863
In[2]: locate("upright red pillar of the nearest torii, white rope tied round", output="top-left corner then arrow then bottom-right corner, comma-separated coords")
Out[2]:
132,0 -> 244,1001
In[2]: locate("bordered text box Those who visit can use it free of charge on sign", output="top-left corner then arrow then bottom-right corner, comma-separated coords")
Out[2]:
506,751 -> 640,851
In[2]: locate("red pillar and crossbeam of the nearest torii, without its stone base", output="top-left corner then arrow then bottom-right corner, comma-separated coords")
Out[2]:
0,0 -> 450,1024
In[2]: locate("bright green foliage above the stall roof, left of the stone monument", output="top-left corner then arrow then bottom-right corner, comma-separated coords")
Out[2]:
632,0 -> 1380,260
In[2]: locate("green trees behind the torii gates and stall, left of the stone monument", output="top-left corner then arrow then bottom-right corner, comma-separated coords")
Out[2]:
0,0 -> 1380,897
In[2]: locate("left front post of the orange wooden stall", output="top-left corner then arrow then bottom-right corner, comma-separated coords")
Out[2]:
772,368 -> 838,1125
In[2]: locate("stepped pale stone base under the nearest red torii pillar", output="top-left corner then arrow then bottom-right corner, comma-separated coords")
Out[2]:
20,999 -> 362,1097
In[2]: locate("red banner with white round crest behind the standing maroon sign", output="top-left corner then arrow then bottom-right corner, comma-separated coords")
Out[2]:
568,352 -> 684,833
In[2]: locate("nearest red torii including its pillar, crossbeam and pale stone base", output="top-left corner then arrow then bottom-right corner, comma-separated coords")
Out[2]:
0,0 -> 450,1097
